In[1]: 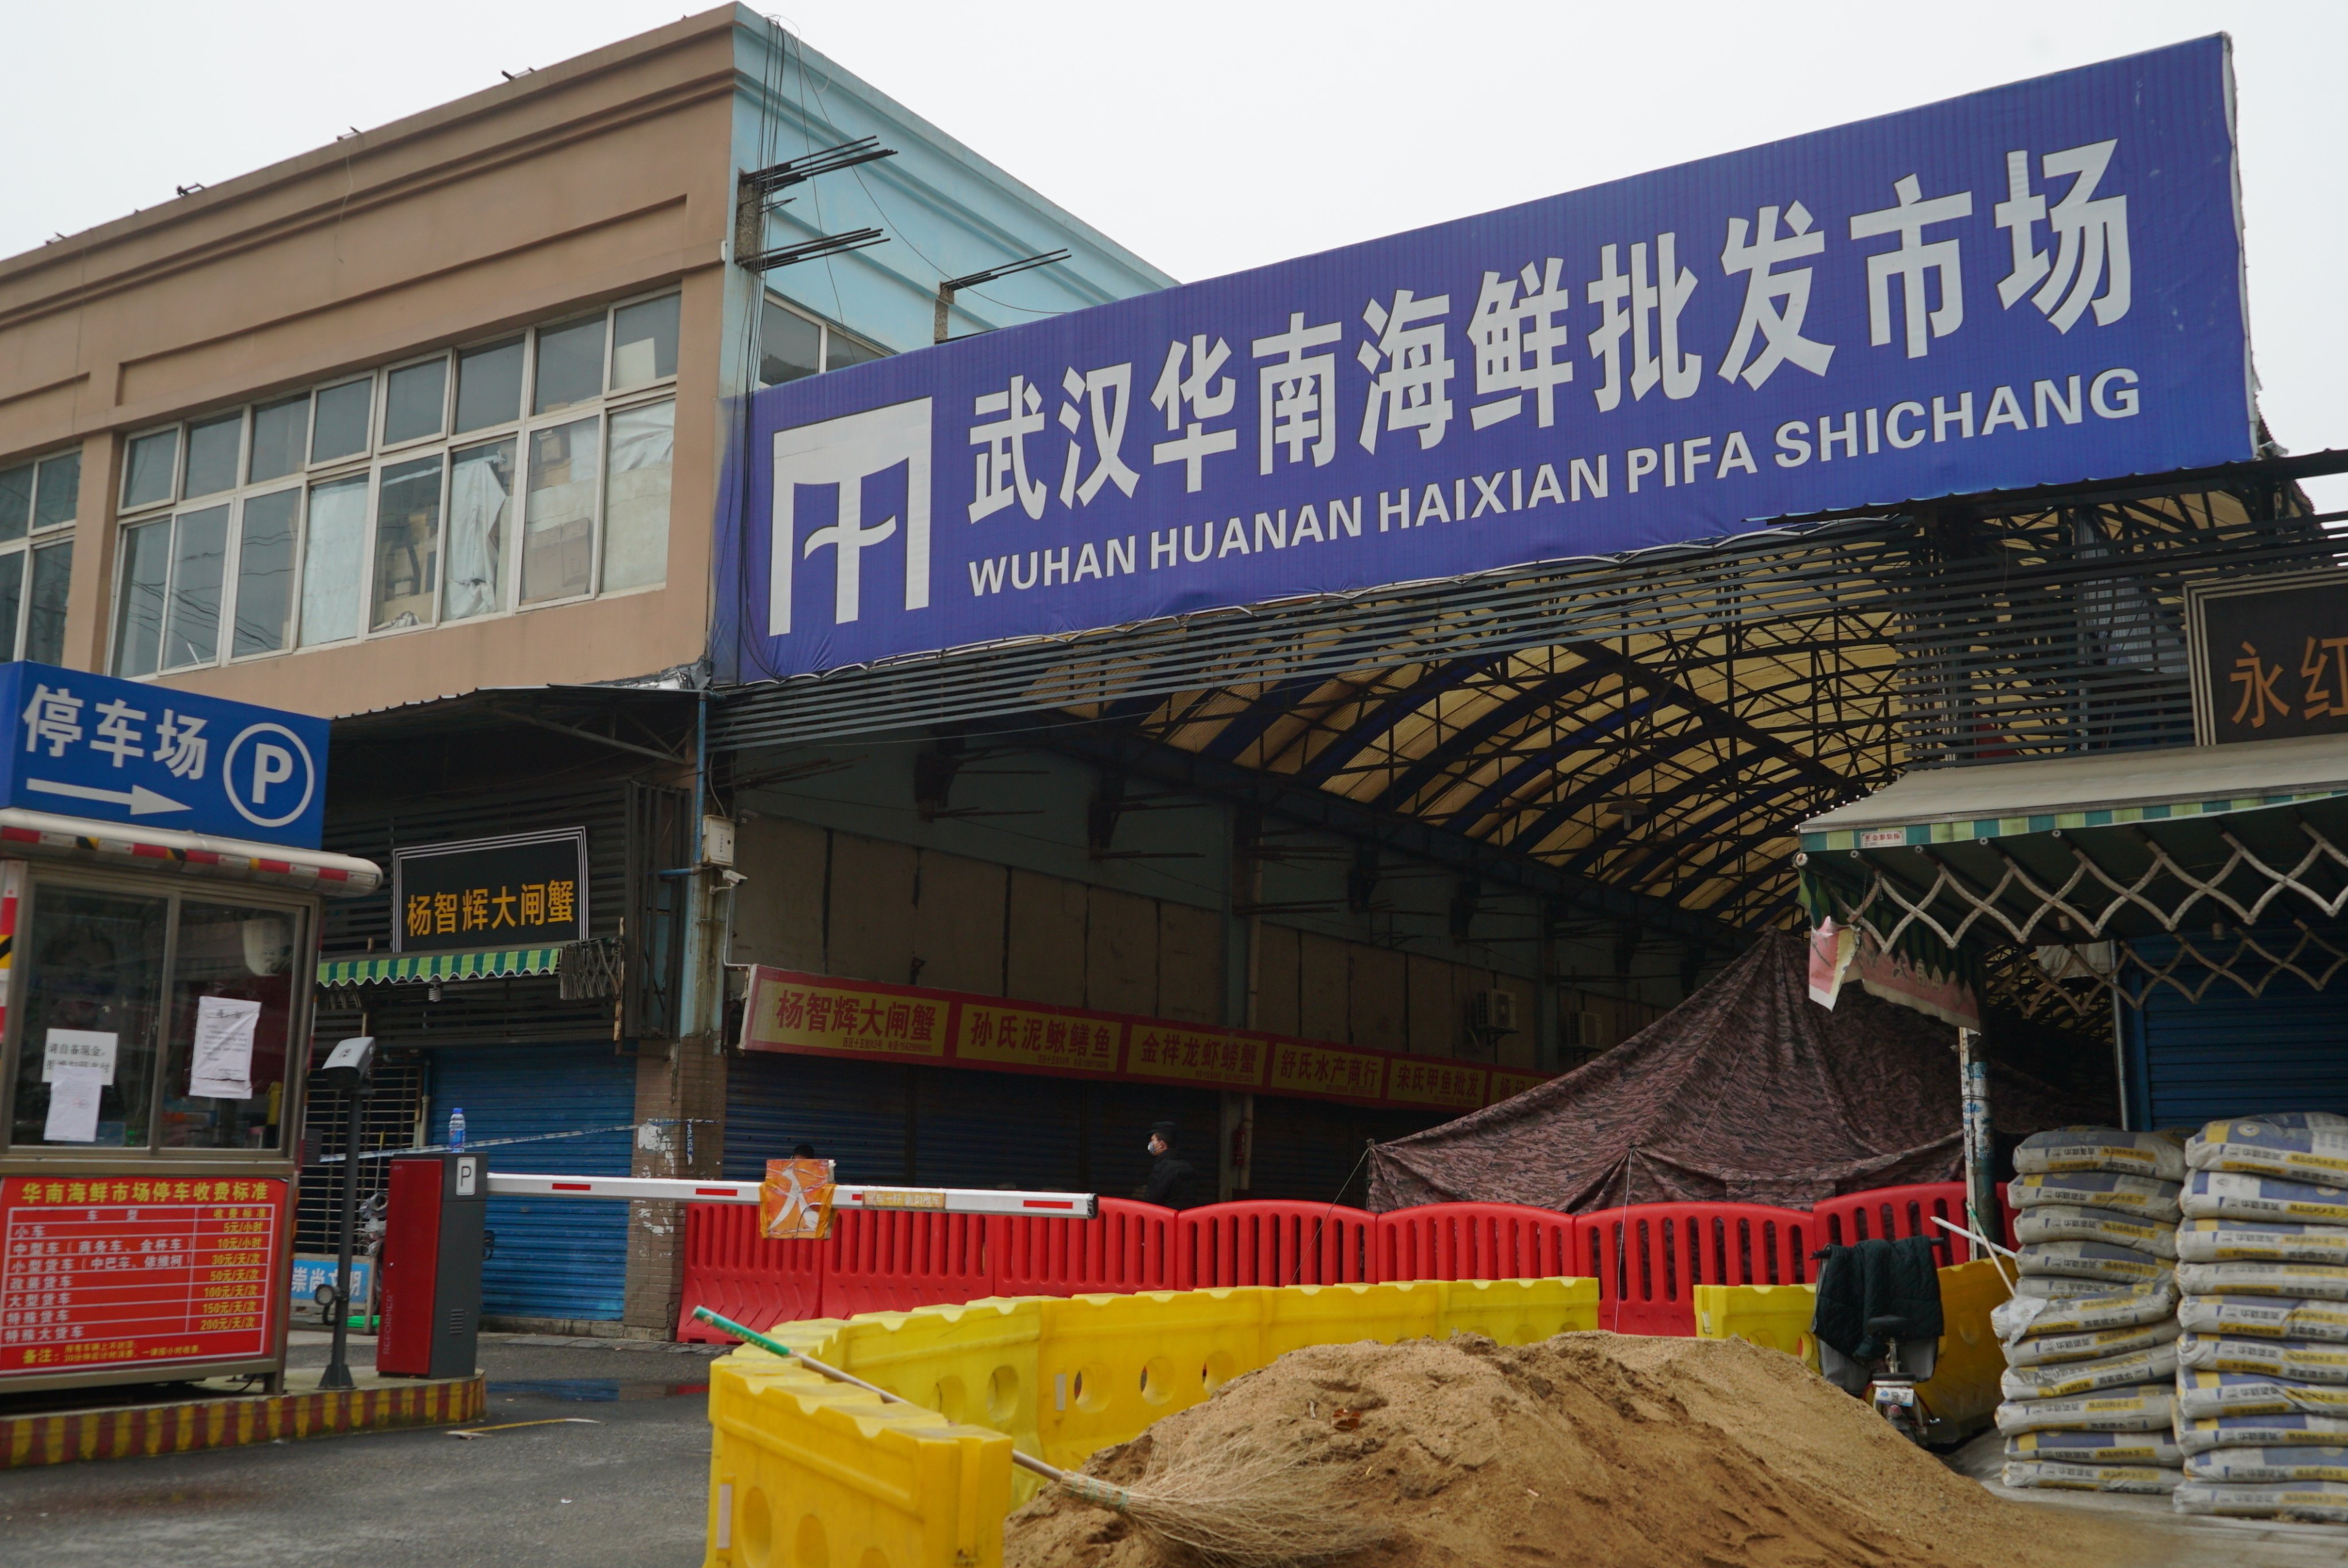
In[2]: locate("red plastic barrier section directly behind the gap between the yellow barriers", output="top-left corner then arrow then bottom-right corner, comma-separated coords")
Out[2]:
1573,1204 -> 1818,1336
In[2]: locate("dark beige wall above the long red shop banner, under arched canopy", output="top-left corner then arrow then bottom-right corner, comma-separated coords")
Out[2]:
733,732 -> 1681,1068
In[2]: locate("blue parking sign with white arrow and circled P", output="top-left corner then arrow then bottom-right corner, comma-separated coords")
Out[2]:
0,662 -> 326,850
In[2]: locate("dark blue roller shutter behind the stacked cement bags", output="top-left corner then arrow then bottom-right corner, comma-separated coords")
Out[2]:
2120,937 -> 2348,1127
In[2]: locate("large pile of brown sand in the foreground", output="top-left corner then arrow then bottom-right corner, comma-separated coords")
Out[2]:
1003,1334 -> 2162,1568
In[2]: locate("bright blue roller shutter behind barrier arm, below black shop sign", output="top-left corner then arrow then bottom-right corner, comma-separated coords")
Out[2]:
432,1042 -> 636,1319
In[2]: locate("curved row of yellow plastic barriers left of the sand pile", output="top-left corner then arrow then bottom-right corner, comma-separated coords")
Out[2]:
705,1279 -> 1599,1568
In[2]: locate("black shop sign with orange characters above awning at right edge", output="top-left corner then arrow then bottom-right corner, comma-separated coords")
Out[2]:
2186,570 -> 2348,746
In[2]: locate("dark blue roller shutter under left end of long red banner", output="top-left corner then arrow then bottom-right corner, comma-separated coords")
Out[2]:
723,1051 -> 916,1180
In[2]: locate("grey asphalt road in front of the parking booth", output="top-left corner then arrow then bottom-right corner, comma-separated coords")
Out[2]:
0,1340 -> 709,1568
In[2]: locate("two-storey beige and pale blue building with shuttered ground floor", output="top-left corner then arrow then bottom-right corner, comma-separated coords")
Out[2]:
0,7 -> 1655,1334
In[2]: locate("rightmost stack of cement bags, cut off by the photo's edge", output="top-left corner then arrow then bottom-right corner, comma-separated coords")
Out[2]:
2174,1113 -> 2348,1521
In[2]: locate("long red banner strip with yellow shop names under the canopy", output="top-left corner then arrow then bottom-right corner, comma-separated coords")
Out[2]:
742,967 -> 1550,1110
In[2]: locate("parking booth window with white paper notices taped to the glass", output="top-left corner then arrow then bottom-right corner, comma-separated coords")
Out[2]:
9,880 -> 310,1150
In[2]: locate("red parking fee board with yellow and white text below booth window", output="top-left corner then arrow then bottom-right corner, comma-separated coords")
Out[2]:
0,1174 -> 287,1378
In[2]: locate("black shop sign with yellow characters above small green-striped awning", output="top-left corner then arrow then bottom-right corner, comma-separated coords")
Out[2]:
392,828 -> 587,953
